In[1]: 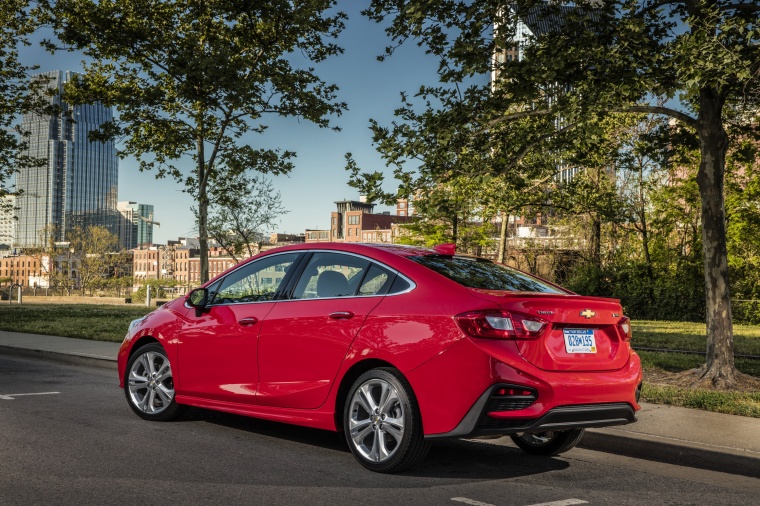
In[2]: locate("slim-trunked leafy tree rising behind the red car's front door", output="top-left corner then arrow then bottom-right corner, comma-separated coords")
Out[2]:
53,0 -> 345,282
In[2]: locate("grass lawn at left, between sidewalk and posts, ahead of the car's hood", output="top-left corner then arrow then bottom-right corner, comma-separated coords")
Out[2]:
0,304 -> 155,343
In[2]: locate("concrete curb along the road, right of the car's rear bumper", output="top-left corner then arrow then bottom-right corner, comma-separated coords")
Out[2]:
578,429 -> 760,478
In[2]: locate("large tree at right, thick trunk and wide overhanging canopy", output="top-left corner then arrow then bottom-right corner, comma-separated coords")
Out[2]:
365,0 -> 760,387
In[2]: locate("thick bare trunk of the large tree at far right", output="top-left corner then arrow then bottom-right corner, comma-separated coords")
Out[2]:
697,88 -> 736,388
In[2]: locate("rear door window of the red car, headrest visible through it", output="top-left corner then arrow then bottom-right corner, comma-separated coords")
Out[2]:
293,252 -> 370,299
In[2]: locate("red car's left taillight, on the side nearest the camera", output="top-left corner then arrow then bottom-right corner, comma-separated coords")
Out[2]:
455,310 -> 549,339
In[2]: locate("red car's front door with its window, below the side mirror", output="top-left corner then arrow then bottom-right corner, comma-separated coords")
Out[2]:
177,252 -> 299,404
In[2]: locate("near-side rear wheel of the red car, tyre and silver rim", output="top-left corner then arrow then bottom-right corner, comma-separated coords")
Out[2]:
343,368 -> 430,473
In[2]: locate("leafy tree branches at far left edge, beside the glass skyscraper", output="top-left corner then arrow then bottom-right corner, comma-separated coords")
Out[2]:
0,0 -> 46,201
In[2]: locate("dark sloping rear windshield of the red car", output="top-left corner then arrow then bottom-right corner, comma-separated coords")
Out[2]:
407,255 -> 568,293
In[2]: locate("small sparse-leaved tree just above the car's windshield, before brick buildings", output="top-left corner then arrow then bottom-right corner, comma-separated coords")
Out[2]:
203,174 -> 288,262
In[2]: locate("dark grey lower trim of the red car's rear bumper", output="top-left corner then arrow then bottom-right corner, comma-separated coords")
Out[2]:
425,385 -> 636,439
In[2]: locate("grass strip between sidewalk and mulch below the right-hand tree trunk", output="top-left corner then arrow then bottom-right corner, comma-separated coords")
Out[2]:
641,381 -> 760,418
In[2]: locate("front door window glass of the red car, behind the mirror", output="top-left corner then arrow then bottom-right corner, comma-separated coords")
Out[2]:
213,253 -> 298,305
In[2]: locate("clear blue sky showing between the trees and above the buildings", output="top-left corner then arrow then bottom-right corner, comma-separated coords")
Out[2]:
17,0 -> 476,244
